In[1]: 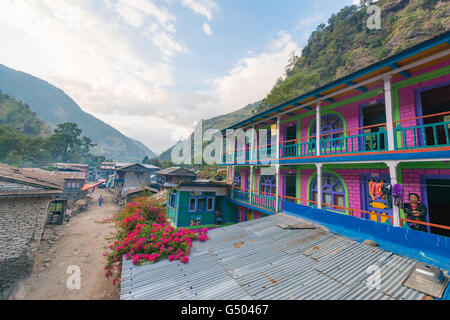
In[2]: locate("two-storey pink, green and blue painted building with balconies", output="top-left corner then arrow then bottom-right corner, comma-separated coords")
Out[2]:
222,33 -> 450,237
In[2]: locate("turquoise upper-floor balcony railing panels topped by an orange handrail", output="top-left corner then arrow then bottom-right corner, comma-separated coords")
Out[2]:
224,111 -> 450,163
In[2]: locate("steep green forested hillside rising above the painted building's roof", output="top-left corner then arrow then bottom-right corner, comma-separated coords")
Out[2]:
255,0 -> 450,112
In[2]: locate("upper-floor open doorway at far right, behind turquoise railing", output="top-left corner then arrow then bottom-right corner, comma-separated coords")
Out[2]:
418,84 -> 450,146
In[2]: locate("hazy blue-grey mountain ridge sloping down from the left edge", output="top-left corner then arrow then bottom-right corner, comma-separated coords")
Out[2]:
0,64 -> 155,162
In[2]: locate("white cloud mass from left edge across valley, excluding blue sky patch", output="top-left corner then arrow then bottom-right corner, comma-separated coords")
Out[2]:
0,0 -> 299,152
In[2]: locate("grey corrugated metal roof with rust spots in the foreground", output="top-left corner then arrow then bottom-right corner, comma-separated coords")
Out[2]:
121,215 -> 440,300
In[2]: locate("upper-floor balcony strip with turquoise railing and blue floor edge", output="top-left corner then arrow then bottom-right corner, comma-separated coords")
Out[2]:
223,111 -> 450,165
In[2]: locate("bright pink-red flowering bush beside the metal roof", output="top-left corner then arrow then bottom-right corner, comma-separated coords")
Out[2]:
103,198 -> 209,284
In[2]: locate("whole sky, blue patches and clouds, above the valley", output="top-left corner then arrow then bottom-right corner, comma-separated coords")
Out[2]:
0,0 -> 355,153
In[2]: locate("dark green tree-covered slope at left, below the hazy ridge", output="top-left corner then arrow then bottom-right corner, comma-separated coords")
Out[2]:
0,93 -> 106,167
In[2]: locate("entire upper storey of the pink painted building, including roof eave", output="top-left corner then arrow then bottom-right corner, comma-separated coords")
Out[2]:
222,33 -> 450,165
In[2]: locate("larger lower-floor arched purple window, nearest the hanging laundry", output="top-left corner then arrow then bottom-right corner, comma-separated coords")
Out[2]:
311,173 -> 345,211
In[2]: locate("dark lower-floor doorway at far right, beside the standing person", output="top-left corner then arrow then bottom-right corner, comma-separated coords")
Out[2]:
425,177 -> 450,237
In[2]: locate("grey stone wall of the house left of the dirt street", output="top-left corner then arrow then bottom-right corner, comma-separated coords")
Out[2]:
0,197 -> 51,299
